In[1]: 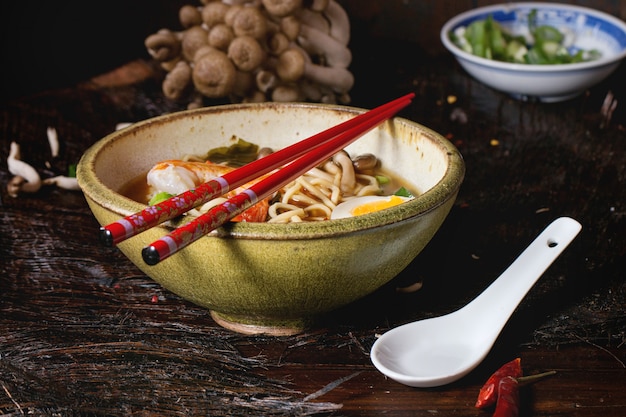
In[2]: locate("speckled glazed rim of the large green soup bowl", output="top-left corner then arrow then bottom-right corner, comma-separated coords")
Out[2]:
77,102 -> 465,240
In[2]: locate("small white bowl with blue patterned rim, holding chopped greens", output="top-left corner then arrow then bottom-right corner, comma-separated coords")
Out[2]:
440,2 -> 626,102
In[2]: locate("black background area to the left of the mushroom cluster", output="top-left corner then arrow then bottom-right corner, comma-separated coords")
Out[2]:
0,0 -> 180,98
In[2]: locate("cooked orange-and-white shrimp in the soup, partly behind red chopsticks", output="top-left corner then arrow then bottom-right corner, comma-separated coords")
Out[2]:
147,159 -> 271,222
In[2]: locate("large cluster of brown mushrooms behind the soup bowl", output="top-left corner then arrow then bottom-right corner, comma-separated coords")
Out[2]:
145,0 -> 354,108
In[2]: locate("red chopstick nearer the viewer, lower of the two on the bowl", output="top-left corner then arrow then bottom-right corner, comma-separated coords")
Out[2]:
141,99 -> 411,265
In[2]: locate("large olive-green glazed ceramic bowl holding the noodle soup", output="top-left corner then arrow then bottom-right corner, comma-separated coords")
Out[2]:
77,103 -> 465,335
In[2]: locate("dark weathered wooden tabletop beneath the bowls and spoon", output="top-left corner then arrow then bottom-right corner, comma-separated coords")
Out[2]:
0,34 -> 626,417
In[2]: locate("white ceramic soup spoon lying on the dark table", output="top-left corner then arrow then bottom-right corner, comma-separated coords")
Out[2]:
371,217 -> 582,387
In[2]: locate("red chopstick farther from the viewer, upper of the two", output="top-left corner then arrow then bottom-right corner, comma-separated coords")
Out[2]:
100,93 -> 415,246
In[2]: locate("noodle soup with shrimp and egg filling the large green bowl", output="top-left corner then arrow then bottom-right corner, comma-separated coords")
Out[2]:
123,142 -> 414,223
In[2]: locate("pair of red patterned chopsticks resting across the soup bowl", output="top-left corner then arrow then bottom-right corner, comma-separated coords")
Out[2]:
100,93 -> 415,265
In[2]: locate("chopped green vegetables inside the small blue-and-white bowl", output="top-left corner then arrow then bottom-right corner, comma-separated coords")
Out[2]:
450,10 -> 601,65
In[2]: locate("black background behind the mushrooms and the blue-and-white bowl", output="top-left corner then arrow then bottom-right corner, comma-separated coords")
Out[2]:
0,0 -> 626,99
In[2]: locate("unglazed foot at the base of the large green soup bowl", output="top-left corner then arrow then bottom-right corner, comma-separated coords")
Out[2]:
210,310 -> 308,336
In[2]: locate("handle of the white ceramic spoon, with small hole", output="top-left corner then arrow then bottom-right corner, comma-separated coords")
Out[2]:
459,217 -> 582,334
